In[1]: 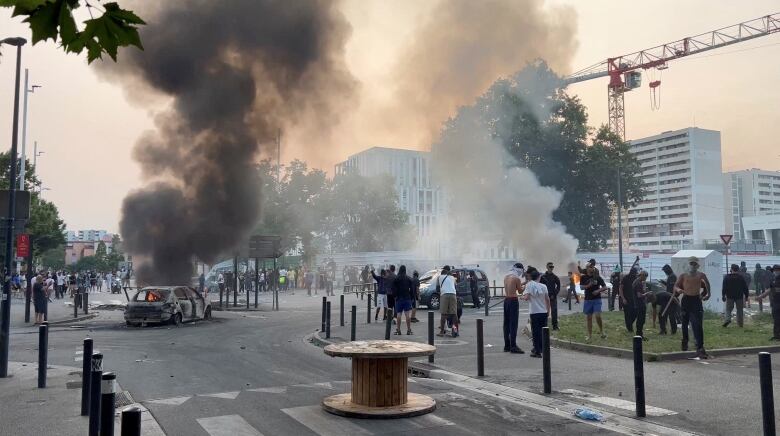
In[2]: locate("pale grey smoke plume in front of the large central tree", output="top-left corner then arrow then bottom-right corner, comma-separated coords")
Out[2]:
431,63 -> 577,267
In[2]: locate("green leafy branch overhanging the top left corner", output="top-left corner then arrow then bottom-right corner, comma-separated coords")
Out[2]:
0,0 -> 146,63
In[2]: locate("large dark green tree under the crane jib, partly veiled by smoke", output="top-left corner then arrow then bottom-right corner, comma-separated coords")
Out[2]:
442,62 -> 644,250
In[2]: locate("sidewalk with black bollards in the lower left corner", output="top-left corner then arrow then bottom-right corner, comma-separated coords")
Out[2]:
0,362 -> 164,436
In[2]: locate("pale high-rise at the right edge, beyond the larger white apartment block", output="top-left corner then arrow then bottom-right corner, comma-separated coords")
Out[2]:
723,168 -> 780,239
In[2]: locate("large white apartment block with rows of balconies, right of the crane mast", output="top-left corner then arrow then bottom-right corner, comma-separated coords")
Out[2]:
627,127 -> 725,251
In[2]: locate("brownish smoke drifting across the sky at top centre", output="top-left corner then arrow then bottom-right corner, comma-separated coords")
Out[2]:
358,0 -> 577,149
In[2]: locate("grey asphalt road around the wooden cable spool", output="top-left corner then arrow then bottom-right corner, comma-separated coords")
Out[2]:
4,292 -> 780,436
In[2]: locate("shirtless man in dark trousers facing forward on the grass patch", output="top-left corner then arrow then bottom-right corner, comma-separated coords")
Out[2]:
674,256 -> 710,359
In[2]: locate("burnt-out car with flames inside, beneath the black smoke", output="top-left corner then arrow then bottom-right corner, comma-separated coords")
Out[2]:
125,286 -> 211,326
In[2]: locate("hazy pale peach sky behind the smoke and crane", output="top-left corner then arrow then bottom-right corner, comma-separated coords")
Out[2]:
0,0 -> 780,235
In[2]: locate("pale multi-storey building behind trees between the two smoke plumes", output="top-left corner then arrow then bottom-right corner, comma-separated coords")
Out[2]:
335,147 -> 444,238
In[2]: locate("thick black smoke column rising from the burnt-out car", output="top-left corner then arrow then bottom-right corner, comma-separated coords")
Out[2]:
101,0 -> 355,284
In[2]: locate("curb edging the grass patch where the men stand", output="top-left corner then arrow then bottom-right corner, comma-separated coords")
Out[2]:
550,338 -> 780,362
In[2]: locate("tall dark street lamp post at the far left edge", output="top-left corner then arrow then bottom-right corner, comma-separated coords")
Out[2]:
0,37 -> 27,378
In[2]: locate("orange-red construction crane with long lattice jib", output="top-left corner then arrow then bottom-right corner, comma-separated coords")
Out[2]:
564,13 -> 780,140
